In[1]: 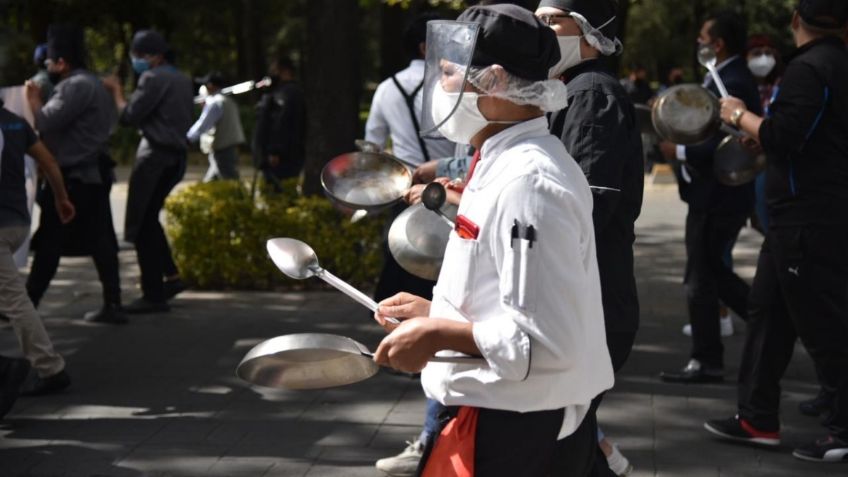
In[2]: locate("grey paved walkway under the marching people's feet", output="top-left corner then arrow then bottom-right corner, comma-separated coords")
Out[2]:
0,179 -> 848,477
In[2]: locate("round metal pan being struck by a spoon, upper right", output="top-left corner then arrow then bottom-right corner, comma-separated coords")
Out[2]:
651,84 -> 721,145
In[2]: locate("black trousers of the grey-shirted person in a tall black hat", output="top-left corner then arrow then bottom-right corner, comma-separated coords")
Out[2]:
26,180 -> 121,305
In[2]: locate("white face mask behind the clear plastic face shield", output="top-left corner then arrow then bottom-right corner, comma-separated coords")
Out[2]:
432,82 -> 489,144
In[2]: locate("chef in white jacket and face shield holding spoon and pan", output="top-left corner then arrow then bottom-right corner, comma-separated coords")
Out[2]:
375,5 -> 613,477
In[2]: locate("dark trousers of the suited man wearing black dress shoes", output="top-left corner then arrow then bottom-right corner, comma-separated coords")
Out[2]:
683,211 -> 750,368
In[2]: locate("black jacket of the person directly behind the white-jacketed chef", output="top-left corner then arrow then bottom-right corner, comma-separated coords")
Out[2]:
550,60 -> 644,332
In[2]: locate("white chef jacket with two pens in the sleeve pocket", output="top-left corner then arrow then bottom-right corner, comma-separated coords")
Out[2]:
421,117 -> 613,438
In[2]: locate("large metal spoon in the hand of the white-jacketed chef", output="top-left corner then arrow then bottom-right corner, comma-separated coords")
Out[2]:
265,238 -> 400,324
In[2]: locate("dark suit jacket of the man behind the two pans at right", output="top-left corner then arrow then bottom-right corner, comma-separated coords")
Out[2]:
678,57 -> 762,215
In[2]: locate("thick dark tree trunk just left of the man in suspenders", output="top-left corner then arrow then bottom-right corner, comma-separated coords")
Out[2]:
303,0 -> 361,195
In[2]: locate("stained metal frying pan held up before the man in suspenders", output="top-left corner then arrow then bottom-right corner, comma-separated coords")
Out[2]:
321,152 -> 415,212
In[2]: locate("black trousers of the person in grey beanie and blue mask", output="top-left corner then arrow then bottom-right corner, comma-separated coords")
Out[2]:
135,163 -> 184,303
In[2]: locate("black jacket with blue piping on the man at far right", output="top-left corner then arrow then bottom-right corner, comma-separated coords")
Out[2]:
760,38 -> 848,227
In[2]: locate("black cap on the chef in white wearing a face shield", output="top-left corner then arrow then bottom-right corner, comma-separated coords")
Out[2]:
457,4 -> 560,81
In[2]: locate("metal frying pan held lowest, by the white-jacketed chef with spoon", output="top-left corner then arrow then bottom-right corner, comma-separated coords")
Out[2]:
236,333 -> 486,389
